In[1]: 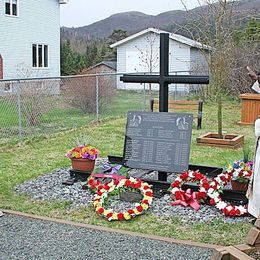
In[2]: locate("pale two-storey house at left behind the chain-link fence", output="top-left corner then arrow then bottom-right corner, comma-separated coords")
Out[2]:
0,0 -> 68,79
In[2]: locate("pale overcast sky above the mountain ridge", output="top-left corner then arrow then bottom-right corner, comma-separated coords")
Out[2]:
61,0 -> 203,27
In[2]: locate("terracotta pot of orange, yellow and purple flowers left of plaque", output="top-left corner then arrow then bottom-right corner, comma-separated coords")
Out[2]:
66,144 -> 99,172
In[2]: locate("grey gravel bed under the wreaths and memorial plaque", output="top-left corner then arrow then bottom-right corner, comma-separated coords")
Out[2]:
15,165 -> 252,223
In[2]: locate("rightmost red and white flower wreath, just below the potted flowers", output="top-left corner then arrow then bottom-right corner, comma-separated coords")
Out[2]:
207,172 -> 247,216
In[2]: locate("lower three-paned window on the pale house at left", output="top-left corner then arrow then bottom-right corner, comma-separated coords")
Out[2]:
32,44 -> 49,68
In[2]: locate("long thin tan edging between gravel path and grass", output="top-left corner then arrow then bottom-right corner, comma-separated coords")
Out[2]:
0,209 -> 220,249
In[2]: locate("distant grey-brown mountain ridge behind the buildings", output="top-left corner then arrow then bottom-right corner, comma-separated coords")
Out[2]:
61,0 -> 260,41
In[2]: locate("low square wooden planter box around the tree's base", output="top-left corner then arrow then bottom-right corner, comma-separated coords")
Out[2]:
197,132 -> 244,149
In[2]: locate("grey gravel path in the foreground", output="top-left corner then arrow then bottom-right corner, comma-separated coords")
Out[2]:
0,214 -> 212,260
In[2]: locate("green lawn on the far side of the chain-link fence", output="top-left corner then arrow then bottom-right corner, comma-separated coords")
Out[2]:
0,90 -> 148,145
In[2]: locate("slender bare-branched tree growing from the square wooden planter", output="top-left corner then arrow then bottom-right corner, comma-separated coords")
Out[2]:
181,0 -> 260,138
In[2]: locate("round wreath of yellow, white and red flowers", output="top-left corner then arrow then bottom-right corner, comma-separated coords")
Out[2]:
93,178 -> 153,221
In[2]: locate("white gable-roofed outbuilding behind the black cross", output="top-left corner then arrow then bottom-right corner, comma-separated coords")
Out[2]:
110,28 -> 210,91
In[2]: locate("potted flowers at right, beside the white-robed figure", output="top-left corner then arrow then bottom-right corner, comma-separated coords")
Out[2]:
227,160 -> 254,191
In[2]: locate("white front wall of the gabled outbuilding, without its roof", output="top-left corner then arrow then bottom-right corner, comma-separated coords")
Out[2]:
117,33 -> 190,90
